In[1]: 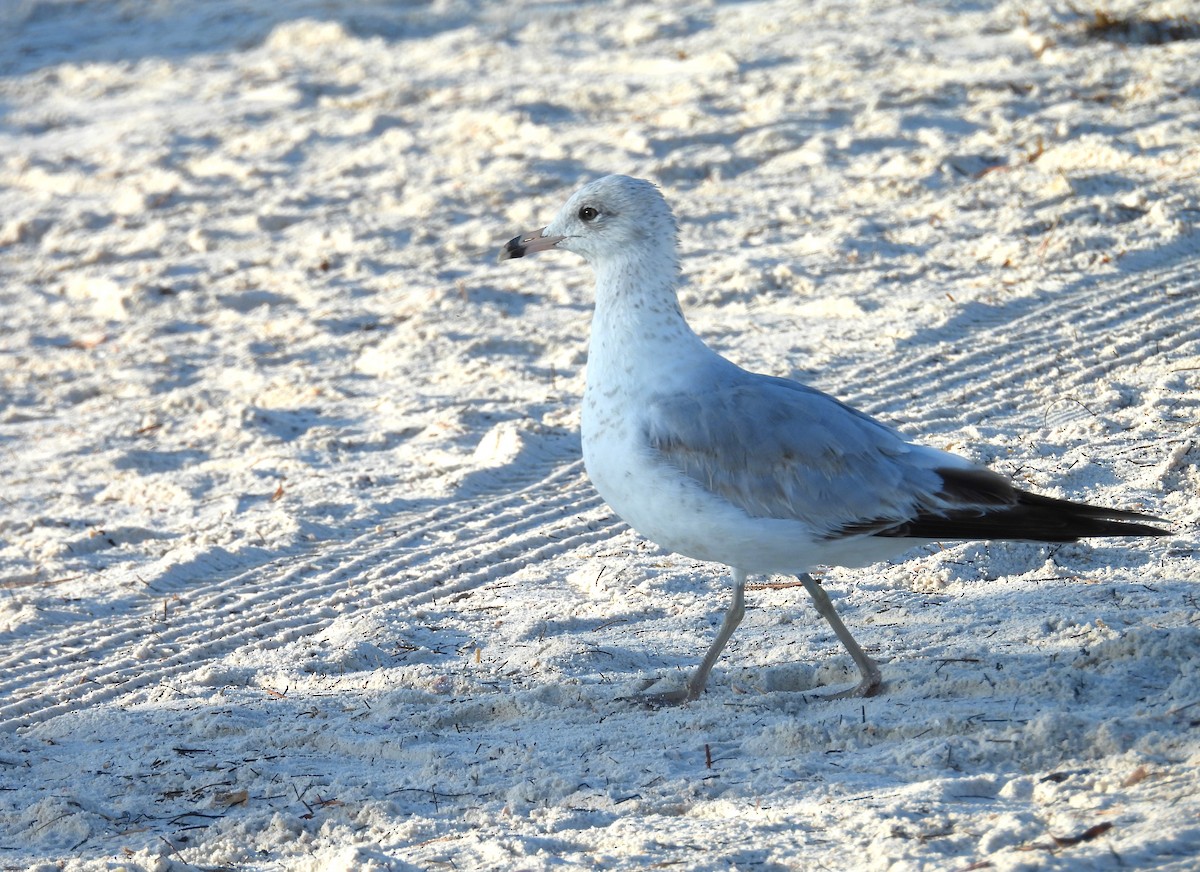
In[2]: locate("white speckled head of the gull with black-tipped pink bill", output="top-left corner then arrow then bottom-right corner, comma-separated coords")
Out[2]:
497,175 -> 676,266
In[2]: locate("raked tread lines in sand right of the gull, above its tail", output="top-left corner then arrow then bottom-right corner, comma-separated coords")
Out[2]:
834,252 -> 1200,443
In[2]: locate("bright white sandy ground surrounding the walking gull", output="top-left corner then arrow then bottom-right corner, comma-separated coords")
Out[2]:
0,0 -> 1200,870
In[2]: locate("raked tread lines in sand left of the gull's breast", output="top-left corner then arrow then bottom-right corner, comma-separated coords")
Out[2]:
0,461 -> 618,729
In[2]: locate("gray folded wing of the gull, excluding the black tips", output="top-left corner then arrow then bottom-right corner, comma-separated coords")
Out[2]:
648,371 -> 949,537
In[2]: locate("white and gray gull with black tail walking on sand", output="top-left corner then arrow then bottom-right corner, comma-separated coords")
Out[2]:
498,175 -> 1166,705
